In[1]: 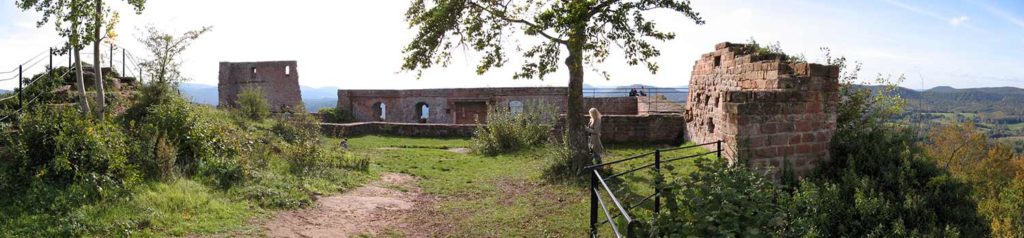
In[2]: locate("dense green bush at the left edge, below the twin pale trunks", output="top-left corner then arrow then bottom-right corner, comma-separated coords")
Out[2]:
0,107 -> 137,200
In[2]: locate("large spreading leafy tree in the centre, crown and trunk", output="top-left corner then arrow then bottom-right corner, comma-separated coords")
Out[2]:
401,0 -> 703,171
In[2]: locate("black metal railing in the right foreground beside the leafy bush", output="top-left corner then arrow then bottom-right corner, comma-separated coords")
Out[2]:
585,141 -> 722,237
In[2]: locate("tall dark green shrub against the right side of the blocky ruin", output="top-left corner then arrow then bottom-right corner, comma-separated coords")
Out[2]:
797,52 -> 988,237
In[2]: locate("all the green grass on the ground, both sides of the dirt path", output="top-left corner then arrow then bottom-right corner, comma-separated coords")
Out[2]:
0,134 -> 705,237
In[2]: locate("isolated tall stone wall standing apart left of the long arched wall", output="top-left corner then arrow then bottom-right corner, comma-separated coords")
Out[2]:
217,62 -> 302,112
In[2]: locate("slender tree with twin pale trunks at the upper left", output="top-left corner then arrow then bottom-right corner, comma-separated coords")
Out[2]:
14,0 -> 145,113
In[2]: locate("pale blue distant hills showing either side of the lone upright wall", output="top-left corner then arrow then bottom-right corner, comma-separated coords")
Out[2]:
178,83 -> 338,112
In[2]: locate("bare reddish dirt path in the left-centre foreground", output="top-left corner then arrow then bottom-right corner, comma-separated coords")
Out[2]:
264,173 -> 422,237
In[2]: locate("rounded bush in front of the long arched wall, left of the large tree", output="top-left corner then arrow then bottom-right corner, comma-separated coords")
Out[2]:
473,103 -> 557,156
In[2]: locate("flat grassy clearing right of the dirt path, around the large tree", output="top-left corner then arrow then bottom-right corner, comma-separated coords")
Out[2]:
325,136 -> 706,237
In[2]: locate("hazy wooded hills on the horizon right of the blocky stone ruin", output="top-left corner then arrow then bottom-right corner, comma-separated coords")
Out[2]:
861,86 -> 1024,115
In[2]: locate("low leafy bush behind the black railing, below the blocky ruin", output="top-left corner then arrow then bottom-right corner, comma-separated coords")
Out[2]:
643,159 -> 804,237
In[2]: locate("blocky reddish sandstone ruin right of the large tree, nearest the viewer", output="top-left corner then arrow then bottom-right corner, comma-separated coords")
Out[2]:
685,42 -> 839,174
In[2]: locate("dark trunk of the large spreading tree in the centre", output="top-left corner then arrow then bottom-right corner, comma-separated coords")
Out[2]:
565,16 -> 593,174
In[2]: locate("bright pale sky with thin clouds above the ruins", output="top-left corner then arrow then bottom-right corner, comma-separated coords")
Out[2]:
0,0 -> 1024,89
